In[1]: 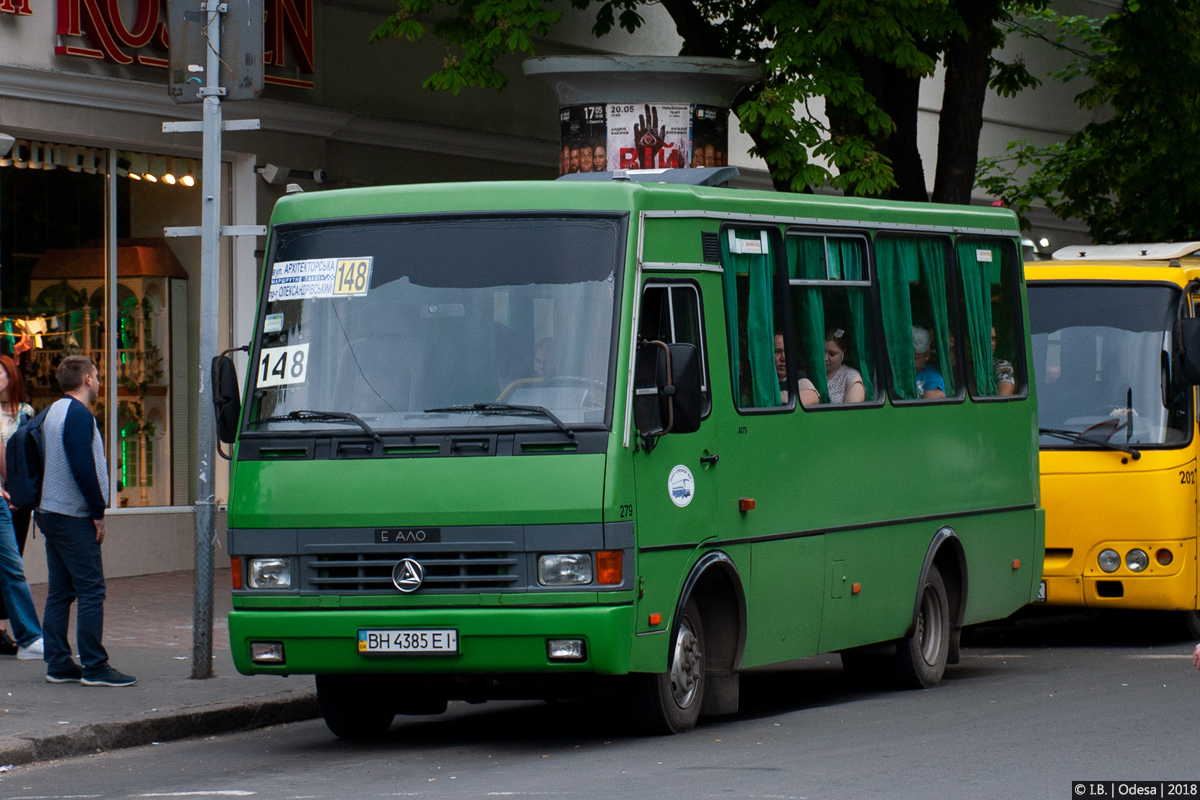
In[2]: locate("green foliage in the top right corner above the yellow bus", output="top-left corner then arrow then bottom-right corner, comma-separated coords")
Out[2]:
977,0 -> 1200,242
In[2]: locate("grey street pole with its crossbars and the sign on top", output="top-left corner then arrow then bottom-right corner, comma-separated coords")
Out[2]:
162,0 -> 266,678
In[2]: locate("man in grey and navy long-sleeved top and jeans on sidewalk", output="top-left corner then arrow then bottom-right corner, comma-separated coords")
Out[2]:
35,355 -> 138,686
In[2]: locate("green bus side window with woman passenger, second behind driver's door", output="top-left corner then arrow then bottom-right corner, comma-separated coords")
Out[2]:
787,234 -> 878,403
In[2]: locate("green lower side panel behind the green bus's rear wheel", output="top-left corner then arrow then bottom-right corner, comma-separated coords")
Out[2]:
950,509 -> 1042,625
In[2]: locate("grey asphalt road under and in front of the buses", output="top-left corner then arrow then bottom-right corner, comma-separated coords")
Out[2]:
0,615 -> 1200,800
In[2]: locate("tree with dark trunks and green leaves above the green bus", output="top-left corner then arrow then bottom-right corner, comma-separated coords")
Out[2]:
371,0 -> 1045,203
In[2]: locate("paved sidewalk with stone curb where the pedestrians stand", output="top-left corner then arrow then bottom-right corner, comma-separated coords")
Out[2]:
0,570 -> 318,766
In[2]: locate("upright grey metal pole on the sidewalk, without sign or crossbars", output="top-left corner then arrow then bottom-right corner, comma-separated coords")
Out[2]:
192,0 -> 221,678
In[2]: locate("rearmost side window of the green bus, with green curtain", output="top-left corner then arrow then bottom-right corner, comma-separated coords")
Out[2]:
954,237 -> 1025,397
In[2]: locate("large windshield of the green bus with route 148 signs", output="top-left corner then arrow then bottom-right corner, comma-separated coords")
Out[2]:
246,215 -> 624,432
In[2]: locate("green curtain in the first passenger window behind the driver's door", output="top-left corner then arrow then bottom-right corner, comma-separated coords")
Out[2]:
721,230 -> 780,408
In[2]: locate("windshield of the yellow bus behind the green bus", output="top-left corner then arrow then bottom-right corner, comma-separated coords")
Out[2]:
1028,282 -> 1190,449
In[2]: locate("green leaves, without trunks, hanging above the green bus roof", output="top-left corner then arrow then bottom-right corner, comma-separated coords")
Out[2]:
371,0 -> 1045,196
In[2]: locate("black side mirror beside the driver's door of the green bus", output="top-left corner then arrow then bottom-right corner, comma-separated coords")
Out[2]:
634,341 -> 702,451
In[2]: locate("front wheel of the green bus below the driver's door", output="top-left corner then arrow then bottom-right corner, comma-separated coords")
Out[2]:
630,599 -> 707,736
